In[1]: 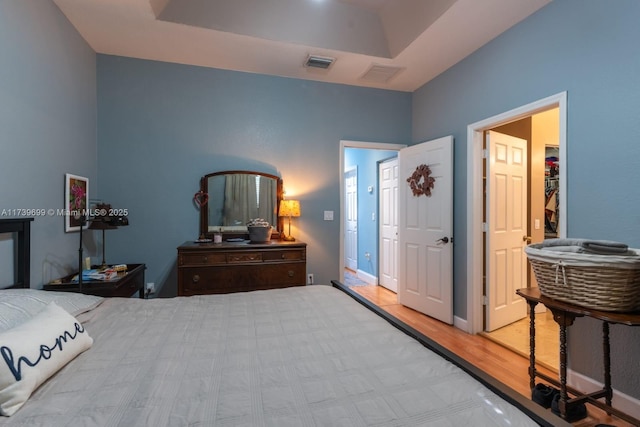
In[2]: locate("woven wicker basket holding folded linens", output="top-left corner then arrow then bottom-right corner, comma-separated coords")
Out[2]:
525,244 -> 640,312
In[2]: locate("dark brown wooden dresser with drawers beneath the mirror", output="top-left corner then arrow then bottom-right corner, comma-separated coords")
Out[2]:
178,240 -> 307,296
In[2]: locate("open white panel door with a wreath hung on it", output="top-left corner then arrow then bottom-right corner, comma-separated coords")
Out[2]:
398,136 -> 453,324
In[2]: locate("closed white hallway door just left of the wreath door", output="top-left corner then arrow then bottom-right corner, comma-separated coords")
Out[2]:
378,158 -> 398,292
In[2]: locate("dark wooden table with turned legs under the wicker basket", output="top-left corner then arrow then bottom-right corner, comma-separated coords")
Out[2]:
516,288 -> 640,425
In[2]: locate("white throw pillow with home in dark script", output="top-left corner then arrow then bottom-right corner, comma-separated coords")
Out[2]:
0,302 -> 93,416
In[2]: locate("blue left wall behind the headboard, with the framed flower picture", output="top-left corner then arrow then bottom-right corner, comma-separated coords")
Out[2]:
0,0 -> 97,287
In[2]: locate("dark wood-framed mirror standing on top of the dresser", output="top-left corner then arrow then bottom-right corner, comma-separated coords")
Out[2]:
200,171 -> 282,239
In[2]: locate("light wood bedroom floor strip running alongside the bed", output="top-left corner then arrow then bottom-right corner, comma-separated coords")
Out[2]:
351,286 -> 633,427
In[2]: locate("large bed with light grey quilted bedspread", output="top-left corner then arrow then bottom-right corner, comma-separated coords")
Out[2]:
0,282 -> 569,427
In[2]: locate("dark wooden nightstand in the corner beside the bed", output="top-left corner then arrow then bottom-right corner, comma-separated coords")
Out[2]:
43,264 -> 147,298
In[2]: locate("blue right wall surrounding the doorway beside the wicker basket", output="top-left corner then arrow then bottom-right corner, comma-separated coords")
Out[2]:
412,0 -> 640,398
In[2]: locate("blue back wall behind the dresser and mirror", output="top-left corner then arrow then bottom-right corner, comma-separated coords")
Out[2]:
98,55 -> 411,294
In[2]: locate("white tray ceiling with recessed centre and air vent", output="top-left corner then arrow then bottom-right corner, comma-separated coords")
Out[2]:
54,0 -> 551,92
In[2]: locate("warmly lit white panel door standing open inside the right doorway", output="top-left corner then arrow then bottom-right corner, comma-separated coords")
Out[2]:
485,131 -> 528,331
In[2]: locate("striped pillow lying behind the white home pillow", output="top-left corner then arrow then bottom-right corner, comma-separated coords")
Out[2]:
0,289 -> 104,332
